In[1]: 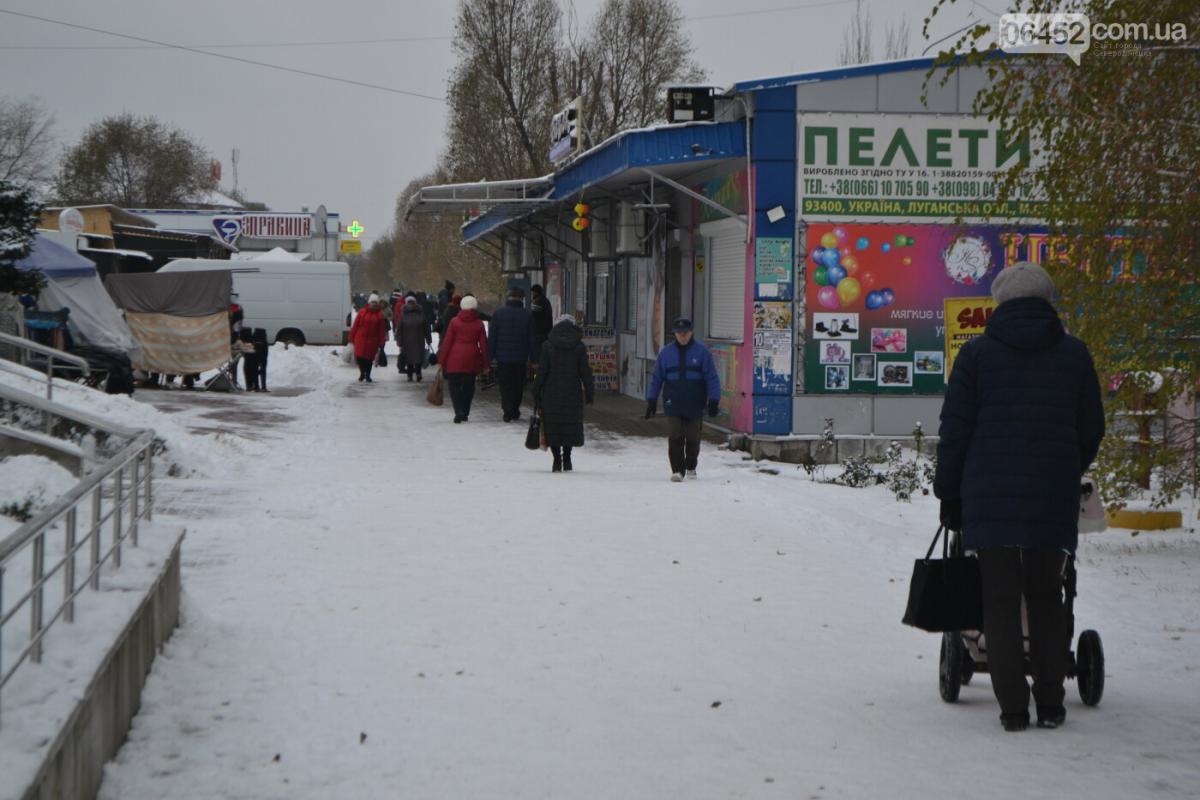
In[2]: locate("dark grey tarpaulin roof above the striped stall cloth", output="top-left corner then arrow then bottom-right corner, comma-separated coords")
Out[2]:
104,270 -> 233,316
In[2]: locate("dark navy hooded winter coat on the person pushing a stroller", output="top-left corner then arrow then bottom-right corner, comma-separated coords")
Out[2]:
934,297 -> 1104,552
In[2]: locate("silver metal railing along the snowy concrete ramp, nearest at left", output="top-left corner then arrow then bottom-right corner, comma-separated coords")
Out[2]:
0,387 -> 155,734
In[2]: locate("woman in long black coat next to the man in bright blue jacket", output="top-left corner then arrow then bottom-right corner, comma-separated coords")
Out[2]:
533,314 -> 595,473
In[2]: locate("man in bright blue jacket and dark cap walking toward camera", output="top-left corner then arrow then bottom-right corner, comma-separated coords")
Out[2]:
646,317 -> 721,482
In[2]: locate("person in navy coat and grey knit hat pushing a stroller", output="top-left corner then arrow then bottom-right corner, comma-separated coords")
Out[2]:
934,263 -> 1104,730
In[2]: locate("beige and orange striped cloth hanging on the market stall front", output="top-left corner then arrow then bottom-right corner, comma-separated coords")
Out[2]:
125,311 -> 229,375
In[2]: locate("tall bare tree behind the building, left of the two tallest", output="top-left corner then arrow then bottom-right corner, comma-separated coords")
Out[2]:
449,0 -> 562,176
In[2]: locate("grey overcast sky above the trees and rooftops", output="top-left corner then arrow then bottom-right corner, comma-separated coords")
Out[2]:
0,0 -> 984,242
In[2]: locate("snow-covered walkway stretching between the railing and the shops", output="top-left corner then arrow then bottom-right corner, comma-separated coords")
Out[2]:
101,348 -> 1200,800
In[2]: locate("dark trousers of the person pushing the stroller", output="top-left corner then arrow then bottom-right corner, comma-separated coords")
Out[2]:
979,547 -> 1070,717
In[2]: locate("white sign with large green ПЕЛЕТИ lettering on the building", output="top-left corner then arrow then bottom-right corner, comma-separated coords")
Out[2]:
798,114 -> 1043,222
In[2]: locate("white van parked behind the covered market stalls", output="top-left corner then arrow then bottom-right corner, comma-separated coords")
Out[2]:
158,258 -> 350,344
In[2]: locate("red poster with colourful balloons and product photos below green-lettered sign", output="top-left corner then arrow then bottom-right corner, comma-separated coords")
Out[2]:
804,223 -> 1022,395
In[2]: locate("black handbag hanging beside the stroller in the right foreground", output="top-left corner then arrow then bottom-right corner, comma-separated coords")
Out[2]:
901,527 -> 983,633
